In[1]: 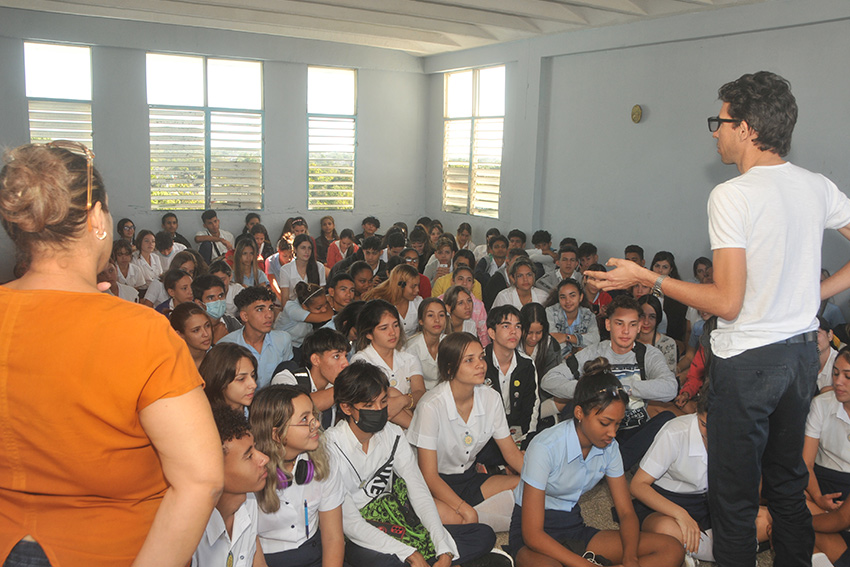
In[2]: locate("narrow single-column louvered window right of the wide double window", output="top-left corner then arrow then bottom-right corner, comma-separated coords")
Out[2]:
307,67 -> 357,211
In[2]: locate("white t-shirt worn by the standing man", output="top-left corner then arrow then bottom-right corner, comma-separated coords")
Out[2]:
708,162 -> 850,358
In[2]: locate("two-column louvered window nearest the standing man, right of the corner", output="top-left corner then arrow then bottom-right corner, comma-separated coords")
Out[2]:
443,66 -> 505,218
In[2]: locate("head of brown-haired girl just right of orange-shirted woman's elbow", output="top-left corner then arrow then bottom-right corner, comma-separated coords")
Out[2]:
198,343 -> 257,417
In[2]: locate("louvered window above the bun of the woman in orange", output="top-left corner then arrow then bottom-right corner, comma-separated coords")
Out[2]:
24,42 -> 94,150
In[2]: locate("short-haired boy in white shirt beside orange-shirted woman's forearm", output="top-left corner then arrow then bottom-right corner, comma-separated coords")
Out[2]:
192,406 -> 269,567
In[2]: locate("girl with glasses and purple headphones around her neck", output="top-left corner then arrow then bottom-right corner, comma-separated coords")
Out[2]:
251,386 -> 345,567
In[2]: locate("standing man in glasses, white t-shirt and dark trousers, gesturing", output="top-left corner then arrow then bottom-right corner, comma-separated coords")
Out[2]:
594,71 -> 850,567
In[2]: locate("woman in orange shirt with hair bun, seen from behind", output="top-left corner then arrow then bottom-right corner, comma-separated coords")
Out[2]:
0,141 -> 223,567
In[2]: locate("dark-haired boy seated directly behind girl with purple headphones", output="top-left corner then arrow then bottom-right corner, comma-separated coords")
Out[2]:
272,329 -> 351,430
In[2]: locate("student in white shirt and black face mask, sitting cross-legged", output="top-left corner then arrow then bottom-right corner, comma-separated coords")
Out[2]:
327,362 -> 496,567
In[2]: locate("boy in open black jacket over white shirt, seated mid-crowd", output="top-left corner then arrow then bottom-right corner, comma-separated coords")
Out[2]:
483,305 -> 540,444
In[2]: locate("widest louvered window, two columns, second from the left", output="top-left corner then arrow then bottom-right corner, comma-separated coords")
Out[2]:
147,53 -> 263,210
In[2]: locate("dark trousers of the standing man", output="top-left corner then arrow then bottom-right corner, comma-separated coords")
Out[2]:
707,342 -> 818,567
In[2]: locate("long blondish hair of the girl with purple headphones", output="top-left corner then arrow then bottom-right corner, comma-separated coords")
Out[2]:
250,384 -> 330,514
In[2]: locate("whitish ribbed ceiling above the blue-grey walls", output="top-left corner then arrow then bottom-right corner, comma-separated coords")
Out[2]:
0,0 -> 764,55
